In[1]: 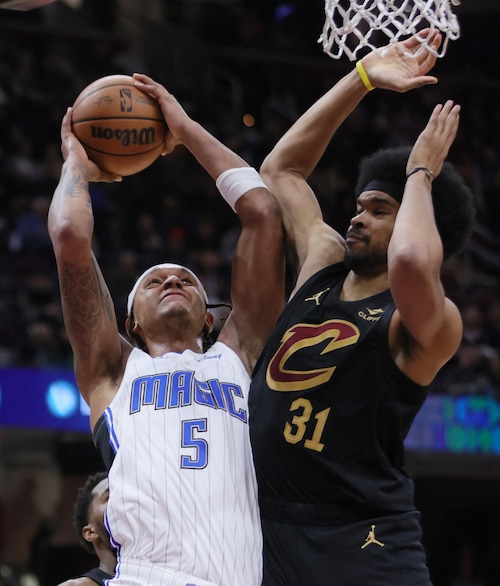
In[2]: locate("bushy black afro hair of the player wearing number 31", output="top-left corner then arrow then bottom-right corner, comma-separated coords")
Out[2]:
355,146 -> 475,260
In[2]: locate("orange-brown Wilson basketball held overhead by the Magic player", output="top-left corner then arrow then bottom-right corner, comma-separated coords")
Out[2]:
72,75 -> 167,176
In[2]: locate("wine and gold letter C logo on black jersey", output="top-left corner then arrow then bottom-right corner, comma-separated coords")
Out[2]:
266,319 -> 360,392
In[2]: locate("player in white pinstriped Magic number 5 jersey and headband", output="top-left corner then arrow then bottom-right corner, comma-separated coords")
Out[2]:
49,74 -> 284,586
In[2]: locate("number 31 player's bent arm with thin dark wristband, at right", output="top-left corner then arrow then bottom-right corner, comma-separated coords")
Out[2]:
387,101 -> 462,384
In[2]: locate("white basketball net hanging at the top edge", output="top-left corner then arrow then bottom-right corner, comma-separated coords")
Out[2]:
318,0 -> 460,61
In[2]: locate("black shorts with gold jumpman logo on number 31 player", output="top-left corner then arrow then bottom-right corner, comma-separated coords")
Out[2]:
262,511 -> 432,586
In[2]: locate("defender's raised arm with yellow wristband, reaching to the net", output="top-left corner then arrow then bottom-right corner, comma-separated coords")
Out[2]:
261,33 -> 441,294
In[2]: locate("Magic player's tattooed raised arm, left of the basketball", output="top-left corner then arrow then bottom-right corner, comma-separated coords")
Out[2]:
48,109 -> 128,410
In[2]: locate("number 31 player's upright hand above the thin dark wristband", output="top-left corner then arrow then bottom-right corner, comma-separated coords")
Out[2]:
406,100 -> 460,177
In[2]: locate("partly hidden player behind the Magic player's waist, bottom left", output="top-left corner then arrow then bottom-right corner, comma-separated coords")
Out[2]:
59,472 -> 116,586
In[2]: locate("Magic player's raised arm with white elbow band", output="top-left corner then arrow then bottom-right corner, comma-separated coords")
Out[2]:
134,74 -> 285,373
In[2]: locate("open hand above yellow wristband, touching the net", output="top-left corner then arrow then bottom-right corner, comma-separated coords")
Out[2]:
361,29 -> 442,93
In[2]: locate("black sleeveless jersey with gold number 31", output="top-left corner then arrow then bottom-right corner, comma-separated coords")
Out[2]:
249,263 -> 426,525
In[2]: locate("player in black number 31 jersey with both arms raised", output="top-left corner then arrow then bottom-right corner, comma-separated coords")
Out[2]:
250,34 -> 474,586
